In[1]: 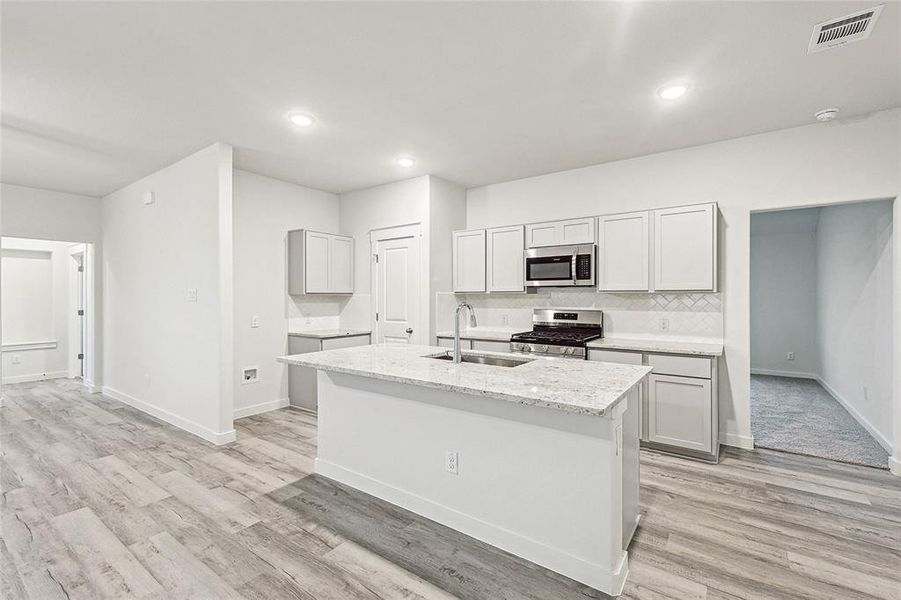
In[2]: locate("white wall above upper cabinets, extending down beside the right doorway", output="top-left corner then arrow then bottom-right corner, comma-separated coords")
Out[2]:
466,109 -> 901,446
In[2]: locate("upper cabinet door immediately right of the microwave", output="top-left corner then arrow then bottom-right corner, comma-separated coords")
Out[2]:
598,212 -> 649,292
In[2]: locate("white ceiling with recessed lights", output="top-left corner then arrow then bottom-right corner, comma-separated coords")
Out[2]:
2,0 -> 901,195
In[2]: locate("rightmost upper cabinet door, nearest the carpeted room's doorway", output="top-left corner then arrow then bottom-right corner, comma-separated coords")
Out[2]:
654,204 -> 716,291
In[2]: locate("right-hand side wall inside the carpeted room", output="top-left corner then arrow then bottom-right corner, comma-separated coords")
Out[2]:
817,202 -> 894,447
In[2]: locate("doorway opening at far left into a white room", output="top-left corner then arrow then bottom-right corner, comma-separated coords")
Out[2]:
0,237 -> 92,392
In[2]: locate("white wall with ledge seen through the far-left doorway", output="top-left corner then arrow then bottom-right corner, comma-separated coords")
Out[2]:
0,238 -> 74,384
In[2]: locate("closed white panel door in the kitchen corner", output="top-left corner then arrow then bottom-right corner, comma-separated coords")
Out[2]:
376,236 -> 426,344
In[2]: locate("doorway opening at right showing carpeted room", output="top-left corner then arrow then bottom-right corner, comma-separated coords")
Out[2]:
751,200 -> 894,469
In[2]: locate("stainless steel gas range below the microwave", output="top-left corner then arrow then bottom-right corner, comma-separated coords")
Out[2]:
510,308 -> 604,358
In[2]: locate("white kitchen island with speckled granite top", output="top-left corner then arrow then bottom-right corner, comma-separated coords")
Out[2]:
279,345 -> 651,595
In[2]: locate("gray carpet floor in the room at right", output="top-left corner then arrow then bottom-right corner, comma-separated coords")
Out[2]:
751,375 -> 888,469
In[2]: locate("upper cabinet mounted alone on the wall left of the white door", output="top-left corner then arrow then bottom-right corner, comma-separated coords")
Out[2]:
288,229 -> 354,296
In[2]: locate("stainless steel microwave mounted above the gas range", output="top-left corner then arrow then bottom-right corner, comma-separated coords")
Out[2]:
525,244 -> 598,287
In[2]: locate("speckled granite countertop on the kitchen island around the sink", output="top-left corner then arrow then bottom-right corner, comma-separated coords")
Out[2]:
278,344 -> 651,416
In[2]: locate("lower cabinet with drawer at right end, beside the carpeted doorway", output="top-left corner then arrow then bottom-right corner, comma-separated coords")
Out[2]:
648,374 -> 713,452
